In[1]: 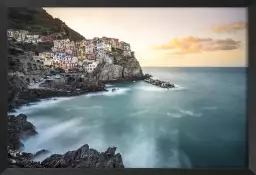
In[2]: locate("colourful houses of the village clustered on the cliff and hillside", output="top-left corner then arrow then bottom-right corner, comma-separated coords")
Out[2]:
7,29 -> 134,73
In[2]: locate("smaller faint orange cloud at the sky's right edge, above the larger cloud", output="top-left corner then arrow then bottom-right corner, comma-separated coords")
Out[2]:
212,21 -> 247,33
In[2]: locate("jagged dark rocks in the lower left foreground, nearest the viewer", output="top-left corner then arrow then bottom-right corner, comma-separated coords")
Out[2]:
7,114 -> 124,168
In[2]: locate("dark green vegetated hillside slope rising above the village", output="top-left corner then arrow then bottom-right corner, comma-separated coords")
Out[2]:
8,7 -> 84,41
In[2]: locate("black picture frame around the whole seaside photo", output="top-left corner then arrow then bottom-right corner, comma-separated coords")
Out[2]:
0,0 -> 256,175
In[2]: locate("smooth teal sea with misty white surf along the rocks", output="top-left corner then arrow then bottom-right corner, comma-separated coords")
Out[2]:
9,67 -> 247,168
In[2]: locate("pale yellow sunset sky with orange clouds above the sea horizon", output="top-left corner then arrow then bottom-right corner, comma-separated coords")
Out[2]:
44,8 -> 247,67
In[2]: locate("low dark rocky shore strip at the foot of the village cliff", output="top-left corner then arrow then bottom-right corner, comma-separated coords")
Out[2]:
8,74 -> 152,112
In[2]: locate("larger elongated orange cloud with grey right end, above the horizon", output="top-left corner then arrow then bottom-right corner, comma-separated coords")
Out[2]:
153,36 -> 241,54
